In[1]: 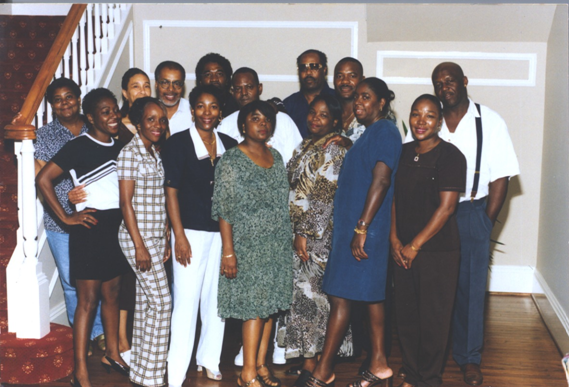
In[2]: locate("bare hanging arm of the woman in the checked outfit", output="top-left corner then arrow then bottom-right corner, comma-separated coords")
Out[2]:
119,180 -> 152,272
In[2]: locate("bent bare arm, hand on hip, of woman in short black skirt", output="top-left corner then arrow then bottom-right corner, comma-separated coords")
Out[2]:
36,162 -> 97,229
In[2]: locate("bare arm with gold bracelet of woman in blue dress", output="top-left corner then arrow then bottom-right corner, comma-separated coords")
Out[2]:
350,162 -> 392,261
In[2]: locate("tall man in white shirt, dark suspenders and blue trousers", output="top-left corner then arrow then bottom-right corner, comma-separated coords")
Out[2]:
402,62 -> 519,385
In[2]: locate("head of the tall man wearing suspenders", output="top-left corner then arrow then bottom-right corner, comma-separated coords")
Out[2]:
432,63 -> 468,109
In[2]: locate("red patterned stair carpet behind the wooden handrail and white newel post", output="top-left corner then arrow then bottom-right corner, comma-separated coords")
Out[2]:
0,15 -> 65,333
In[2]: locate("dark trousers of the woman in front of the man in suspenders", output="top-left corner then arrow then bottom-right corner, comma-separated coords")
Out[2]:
394,251 -> 461,387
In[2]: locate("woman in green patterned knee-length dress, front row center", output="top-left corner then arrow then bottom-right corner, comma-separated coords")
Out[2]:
212,101 -> 293,387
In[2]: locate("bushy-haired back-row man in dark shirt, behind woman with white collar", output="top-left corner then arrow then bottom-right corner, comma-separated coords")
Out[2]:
196,53 -> 240,118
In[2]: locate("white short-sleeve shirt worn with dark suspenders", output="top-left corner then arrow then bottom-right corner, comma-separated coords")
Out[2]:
405,99 -> 520,202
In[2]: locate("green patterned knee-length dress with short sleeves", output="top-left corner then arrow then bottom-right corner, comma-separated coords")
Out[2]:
212,147 -> 293,321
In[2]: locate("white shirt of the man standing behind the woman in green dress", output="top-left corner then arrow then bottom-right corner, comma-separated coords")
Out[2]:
216,110 -> 303,165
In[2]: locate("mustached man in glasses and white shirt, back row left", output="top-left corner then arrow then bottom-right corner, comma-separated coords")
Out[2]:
154,61 -> 192,135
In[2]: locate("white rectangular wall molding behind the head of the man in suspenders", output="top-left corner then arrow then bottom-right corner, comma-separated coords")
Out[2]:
376,50 -> 538,87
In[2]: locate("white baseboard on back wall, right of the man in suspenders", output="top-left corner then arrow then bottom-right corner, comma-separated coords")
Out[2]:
487,265 -> 535,294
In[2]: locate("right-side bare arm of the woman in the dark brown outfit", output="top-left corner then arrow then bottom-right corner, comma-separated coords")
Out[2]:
402,191 -> 459,269
